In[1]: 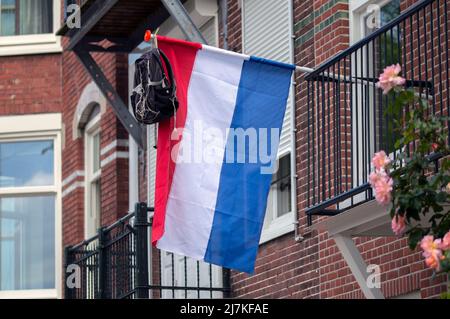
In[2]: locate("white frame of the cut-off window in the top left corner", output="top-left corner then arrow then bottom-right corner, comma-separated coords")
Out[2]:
0,0 -> 62,56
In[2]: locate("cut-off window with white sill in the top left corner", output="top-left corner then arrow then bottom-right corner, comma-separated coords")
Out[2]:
0,0 -> 61,55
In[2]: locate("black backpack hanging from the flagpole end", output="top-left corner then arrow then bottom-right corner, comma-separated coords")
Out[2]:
131,48 -> 178,124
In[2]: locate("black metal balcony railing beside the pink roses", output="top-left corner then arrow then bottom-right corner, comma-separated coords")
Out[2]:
306,0 -> 450,224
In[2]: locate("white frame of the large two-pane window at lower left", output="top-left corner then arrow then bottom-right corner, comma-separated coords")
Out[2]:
0,113 -> 63,299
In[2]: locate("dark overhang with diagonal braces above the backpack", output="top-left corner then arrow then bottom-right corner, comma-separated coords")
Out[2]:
56,0 -> 205,148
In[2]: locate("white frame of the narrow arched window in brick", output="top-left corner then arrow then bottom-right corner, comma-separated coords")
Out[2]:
84,114 -> 102,238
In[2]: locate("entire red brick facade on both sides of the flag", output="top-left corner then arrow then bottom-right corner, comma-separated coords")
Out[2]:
0,0 -> 446,298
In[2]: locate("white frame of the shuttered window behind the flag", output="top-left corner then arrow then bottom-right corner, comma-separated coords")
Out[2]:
239,0 -> 297,245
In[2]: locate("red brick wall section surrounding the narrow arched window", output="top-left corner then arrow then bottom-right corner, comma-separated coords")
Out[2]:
62,41 -> 128,245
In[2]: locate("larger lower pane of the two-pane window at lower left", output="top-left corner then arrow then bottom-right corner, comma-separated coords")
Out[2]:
0,196 -> 55,290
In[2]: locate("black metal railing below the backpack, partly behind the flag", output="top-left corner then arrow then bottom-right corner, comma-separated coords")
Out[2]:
64,203 -> 230,299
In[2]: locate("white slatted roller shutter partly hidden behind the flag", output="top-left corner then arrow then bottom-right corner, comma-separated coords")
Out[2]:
243,0 -> 293,155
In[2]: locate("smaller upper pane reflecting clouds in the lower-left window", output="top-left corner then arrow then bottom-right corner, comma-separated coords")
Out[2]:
0,141 -> 54,187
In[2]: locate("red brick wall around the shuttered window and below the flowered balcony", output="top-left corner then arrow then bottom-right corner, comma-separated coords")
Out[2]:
221,0 -> 446,298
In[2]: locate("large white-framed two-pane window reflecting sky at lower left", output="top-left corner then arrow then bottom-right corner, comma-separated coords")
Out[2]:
0,114 -> 62,298
